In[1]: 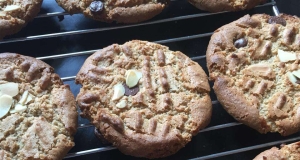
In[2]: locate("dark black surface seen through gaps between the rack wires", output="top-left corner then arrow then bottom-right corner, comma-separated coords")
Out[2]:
0,0 -> 300,160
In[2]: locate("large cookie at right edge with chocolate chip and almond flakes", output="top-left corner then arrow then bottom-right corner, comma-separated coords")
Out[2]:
206,14 -> 300,136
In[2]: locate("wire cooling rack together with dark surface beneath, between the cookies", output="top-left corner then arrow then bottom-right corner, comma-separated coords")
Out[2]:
0,0 -> 300,160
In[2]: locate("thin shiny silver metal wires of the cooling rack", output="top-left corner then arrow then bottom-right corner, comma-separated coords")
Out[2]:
0,1 -> 300,159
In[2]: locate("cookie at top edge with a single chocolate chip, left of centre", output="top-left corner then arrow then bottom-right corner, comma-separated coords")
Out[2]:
56,0 -> 170,23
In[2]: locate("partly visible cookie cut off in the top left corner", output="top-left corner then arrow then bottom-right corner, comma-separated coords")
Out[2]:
0,0 -> 43,39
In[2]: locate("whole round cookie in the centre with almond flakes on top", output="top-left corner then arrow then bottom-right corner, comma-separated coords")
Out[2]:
76,40 -> 212,158
